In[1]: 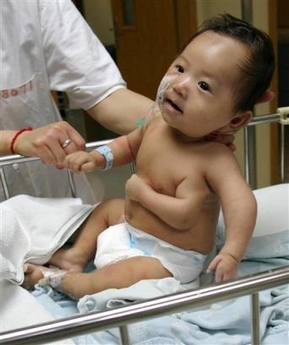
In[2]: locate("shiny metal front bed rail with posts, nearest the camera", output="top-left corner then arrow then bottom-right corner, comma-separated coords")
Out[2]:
0,266 -> 289,345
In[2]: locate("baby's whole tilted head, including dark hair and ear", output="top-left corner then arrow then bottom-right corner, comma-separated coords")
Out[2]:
157,14 -> 274,138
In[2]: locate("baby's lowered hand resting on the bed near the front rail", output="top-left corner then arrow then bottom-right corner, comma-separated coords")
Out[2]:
207,253 -> 238,283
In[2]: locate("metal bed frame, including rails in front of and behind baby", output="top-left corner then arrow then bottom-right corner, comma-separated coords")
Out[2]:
0,107 -> 289,345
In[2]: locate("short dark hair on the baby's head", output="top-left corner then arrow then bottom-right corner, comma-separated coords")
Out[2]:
184,14 -> 275,111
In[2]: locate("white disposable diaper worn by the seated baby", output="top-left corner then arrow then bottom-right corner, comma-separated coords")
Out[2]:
94,223 -> 207,283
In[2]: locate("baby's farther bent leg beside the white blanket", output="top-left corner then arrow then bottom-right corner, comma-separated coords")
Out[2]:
49,199 -> 124,272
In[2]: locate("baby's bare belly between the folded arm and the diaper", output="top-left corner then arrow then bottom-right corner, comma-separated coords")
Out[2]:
125,201 -> 219,254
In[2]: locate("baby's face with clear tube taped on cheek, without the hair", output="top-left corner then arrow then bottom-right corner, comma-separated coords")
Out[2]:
158,31 -> 247,138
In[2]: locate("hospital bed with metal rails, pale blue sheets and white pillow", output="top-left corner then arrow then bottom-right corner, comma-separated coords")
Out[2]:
0,107 -> 289,345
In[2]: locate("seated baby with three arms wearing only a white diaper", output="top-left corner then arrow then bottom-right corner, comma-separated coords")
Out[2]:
26,14 -> 274,299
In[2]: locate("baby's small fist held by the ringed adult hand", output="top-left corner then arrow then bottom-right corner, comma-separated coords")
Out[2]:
63,151 -> 98,173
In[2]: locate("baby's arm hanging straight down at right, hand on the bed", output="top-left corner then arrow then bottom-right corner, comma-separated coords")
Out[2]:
208,147 -> 257,282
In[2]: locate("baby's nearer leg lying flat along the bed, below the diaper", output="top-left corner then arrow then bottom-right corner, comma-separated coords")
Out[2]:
33,256 -> 172,300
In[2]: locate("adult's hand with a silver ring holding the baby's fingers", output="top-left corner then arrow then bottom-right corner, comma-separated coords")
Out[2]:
14,121 -> 85,168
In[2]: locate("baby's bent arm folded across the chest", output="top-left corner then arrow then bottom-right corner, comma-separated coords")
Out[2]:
126,175 -> 207,230
